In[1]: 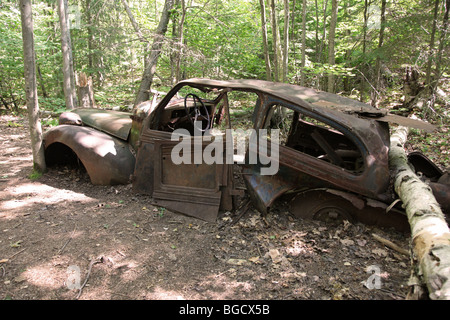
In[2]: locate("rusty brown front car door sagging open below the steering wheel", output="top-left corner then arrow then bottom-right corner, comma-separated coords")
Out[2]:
133,122 -> 233,222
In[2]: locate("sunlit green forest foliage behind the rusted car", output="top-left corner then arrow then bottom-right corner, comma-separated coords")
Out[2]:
0,0 -> 450,116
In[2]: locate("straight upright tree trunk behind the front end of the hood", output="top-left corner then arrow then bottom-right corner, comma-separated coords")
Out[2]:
58,0 -> 77,109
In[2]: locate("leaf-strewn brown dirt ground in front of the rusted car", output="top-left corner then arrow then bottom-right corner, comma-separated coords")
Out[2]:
0,116 -> 416,300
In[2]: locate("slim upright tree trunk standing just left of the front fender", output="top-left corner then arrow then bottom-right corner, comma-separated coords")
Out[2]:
20,0 -> 46,173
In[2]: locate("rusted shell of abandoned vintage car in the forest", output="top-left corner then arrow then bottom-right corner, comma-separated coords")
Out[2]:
44,79 -> 450,225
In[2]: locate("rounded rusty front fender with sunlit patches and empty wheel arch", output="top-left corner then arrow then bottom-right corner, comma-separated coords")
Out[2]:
44,125 -> 136,185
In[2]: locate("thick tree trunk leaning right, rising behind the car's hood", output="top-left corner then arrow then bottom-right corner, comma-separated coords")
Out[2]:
134,0 -> 174,106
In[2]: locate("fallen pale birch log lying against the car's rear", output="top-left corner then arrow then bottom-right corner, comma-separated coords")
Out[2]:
389,127 -> 450,300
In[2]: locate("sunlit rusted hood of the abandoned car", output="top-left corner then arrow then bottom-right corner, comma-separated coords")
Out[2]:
71,108 -> 132,140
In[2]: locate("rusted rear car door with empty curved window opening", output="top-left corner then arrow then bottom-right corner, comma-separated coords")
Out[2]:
244,98 -> 374,212
